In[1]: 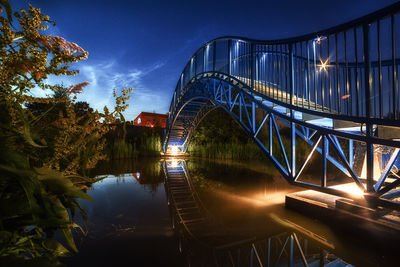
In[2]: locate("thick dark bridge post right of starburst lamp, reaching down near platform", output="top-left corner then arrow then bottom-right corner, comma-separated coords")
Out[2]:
363,24 -> 374,192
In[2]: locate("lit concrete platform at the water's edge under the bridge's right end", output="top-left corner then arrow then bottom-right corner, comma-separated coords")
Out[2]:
285,190 -> 400,240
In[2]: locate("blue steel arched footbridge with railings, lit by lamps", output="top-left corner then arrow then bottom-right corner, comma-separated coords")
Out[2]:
163,3 -> 400,209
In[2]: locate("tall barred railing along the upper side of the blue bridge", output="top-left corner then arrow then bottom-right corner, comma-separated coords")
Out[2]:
170,3 -> 400,125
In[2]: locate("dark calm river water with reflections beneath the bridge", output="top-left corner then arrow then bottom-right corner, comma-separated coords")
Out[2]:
63,159 -> 396,266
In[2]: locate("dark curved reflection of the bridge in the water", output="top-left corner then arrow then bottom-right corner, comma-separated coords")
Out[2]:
164,161 -> 351,267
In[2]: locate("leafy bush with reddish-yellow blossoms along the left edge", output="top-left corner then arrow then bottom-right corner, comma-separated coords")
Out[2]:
0,0 -> 132,266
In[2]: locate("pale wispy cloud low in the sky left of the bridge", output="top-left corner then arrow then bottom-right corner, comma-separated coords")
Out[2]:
32,61 -> 169,120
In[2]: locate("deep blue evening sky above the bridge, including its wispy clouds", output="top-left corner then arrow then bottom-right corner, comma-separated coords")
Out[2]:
14,0 -> 397,120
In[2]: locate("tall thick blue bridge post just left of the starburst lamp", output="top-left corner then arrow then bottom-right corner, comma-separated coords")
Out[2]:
289,44 -> 296,179
